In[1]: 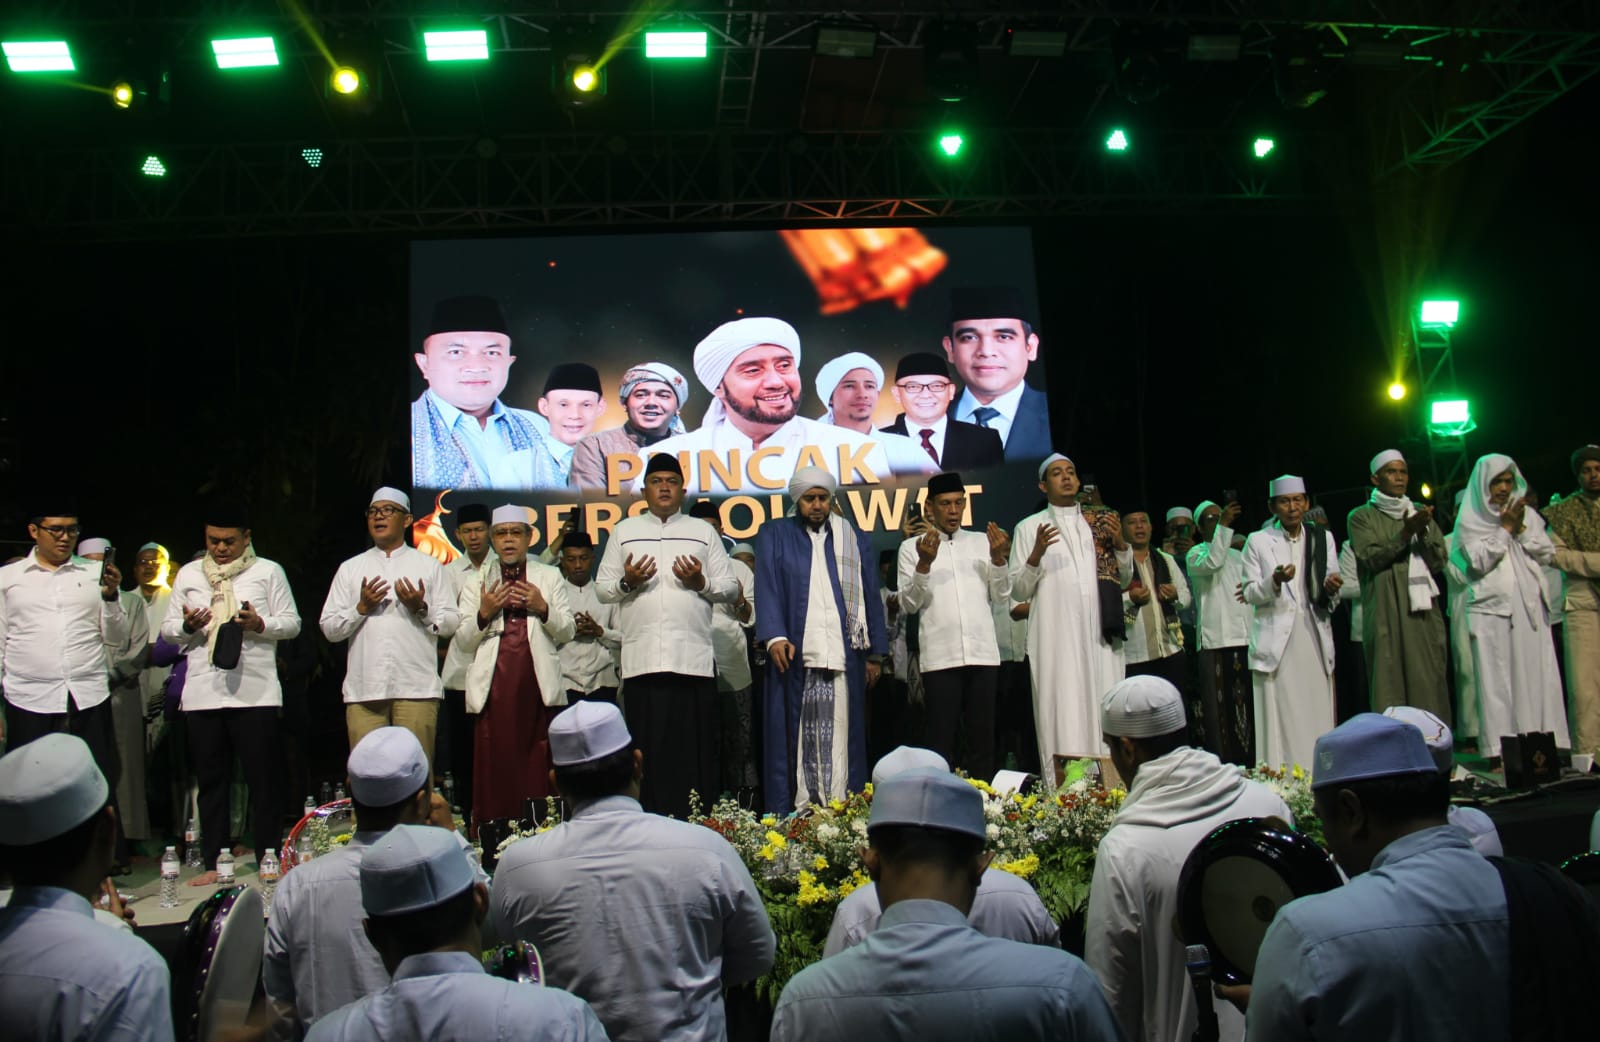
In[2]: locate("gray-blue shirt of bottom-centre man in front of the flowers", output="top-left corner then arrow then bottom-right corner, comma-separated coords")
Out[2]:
771,901 -> 1122,1042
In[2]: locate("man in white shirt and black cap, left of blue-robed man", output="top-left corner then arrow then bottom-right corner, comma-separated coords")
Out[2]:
595,451 -> 739,818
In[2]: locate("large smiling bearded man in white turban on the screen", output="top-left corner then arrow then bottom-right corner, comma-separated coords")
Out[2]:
637,319 -> 891,495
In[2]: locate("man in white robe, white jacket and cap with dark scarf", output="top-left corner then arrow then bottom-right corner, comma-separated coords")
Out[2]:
1245,474 -> 1344,767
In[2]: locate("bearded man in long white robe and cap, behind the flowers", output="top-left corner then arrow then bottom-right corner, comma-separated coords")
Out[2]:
1011,453 -> 1133,771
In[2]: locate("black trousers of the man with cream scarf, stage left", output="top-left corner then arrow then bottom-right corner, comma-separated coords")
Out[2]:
184,706 -> 283,868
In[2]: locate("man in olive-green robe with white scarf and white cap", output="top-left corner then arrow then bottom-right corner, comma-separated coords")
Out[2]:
1346,448 -> 1450,720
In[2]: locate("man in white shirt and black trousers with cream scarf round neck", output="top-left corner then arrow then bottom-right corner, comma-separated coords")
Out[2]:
162,506 -> 301,887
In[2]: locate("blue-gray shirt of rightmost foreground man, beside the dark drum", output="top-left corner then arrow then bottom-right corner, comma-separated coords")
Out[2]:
1248,824 -> 1510,1042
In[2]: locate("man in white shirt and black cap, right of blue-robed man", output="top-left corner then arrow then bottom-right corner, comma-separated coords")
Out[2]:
898,471 -> 1011,778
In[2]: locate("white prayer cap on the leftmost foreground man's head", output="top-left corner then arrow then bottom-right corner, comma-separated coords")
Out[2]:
0,733 -> 110,847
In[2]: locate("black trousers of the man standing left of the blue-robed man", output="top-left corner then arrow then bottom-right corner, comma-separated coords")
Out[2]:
622,672 -> 722,818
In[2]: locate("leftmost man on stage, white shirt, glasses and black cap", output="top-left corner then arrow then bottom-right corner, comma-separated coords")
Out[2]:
0,514 -> 130,809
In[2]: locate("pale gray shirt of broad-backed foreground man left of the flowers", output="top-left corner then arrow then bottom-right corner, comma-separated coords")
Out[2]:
493,796 -> 776,1042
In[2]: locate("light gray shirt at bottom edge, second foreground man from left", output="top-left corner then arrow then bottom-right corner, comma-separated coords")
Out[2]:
306,952 -> 606,1042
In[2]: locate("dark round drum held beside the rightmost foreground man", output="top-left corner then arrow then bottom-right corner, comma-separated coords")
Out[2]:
1178,818 -> 1341,984
